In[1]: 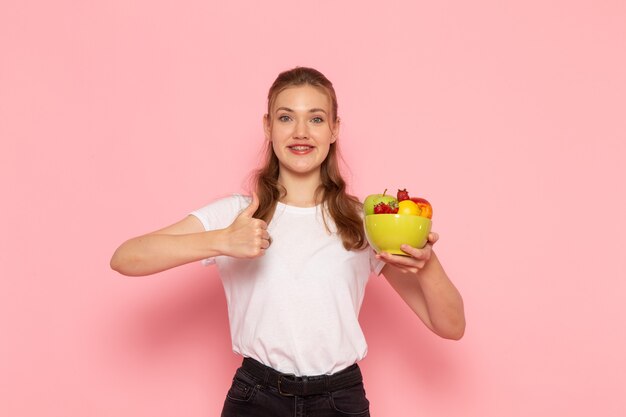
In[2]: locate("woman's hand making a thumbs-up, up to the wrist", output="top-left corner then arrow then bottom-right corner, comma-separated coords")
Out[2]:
224,192 -> 270,258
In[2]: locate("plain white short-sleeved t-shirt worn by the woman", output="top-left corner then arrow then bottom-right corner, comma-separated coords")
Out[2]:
191,195 -> 384,376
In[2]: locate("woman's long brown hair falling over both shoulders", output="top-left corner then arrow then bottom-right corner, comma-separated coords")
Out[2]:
254,67 -> 366,250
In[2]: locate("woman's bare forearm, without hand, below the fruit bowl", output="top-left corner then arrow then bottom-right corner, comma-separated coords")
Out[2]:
417,252 -> 465,339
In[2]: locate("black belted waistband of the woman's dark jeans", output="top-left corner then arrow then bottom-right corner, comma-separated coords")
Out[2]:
241,358 -> 363,396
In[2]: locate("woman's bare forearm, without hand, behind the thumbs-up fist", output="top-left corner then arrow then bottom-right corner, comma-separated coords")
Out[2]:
111,230 -> 223,276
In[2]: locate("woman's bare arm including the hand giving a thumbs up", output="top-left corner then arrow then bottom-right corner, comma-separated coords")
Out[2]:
111,195 -> 269,276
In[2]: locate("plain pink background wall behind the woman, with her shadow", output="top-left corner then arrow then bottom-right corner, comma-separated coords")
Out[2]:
0,0 -> 626,417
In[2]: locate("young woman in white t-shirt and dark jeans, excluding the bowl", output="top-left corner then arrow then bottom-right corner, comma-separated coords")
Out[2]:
111,67 -> 465,417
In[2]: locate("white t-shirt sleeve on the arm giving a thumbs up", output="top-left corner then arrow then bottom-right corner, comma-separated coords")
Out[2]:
189,194 -> 250,265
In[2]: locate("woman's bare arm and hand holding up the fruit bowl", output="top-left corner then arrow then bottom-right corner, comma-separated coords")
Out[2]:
378,234 -> 465,340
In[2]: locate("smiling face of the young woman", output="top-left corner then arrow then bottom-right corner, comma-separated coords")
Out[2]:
264,85 -> 339,180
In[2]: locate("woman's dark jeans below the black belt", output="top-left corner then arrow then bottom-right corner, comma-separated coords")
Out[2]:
222,359 -> 370,417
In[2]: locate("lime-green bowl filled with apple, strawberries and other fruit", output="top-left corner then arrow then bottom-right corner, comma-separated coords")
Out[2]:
363,188 -> 433,256
